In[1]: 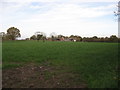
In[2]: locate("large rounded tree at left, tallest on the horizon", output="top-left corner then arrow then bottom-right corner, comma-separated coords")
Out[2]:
7,27 -> 21,40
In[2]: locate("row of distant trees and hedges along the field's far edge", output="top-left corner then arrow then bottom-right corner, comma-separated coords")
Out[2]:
0,27 -> 120,42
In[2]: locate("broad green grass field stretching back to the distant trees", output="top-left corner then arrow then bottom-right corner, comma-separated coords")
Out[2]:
2,41 -> 118,88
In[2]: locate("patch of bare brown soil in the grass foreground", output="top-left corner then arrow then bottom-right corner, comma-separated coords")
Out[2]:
2,64 -> 87,88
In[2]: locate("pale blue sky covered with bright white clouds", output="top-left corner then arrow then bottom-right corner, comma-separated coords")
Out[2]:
0,0 -> 119,38
